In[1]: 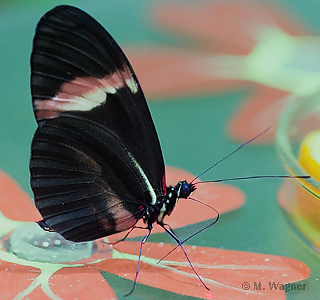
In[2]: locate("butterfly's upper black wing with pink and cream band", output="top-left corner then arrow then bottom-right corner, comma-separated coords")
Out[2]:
31,6 -> 165,194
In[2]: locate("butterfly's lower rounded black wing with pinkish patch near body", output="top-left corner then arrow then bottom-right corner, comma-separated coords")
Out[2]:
30,116 -> 151,242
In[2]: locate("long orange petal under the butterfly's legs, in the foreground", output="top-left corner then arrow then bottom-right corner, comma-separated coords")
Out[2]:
99,241 -> 310,300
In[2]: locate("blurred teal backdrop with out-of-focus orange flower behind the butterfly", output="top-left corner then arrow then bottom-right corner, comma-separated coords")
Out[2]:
0,0 -> 320,299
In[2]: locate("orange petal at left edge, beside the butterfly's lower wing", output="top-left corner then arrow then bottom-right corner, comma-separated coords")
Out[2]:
0,170 -> 41,222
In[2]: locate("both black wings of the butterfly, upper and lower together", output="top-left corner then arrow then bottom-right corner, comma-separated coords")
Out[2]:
30,6 -> 165,241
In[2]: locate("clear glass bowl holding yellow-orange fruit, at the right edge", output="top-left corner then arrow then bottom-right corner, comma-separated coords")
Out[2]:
276,93 -> 320,252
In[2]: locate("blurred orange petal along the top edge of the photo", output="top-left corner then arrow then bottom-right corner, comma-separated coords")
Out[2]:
153,1 -> 306,55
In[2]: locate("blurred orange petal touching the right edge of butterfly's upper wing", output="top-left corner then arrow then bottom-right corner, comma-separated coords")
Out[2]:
126,46 -> 243,100
